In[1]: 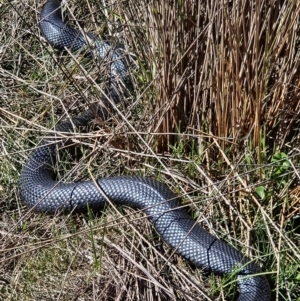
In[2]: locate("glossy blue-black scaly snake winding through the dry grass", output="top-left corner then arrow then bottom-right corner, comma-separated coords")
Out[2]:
20,0 -> 270,301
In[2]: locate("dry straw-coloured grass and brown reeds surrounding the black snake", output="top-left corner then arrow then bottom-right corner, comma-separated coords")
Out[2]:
0,0 -> 300,300
